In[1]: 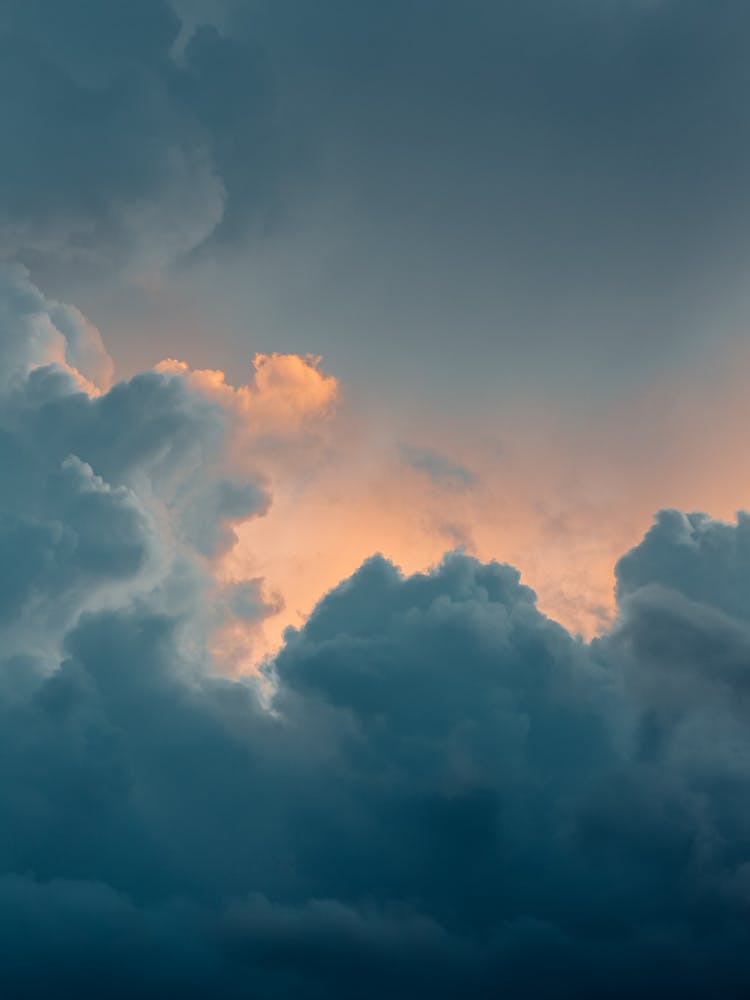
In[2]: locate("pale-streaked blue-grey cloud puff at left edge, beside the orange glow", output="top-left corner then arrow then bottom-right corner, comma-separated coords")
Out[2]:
0,265 -> 268,658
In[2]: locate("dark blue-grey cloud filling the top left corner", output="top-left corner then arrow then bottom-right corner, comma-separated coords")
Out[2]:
0,0 -> 274,271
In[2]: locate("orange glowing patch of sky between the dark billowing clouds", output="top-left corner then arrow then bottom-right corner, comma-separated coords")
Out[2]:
153,344 -> 750,665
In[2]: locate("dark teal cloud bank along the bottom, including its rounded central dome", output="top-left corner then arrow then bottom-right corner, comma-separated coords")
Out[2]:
7,528 -> 750,998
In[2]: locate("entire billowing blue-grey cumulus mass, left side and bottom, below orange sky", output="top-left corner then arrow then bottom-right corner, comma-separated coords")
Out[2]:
0,271 -> 750,1000
